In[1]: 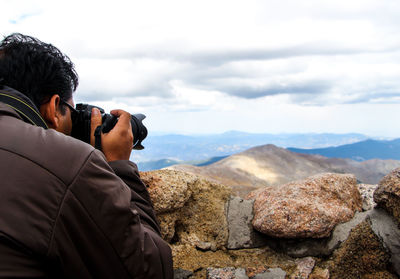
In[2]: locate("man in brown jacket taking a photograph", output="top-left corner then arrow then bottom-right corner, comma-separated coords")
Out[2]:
0,34 -> 172,278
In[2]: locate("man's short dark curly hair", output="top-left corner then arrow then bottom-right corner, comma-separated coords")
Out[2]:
0,33 -> 78,108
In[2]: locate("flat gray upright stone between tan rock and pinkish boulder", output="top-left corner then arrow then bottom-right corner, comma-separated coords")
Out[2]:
227,197 -> 266,249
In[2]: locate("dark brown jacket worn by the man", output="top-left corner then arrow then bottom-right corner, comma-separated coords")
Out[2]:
0,96 -> 173,278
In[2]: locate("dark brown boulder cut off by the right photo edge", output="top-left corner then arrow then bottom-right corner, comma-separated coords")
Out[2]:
374,168 -> 400,222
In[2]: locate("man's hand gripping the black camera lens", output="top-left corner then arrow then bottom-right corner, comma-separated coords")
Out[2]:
90,108 -> 133,162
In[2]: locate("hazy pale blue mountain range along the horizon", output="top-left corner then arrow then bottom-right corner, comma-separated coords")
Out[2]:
131,131 -> 368,165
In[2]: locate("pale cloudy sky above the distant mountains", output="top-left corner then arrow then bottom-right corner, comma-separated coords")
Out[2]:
0,0 -> 400,138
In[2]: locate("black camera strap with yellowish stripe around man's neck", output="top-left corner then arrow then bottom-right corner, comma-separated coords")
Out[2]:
0,86 -> 48,129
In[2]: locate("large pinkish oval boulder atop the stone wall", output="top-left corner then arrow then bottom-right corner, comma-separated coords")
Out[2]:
248,173 -> 362,238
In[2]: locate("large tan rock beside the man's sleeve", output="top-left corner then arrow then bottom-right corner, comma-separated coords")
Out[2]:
141,170 -> 231,247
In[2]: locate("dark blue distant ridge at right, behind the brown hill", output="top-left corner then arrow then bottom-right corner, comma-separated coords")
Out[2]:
288,139 -> 400,161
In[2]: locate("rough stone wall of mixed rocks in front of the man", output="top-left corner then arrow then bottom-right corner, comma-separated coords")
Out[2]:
141,169 -> 400,279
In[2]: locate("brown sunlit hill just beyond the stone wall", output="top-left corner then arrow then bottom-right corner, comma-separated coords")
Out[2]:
169,144 -> 400,196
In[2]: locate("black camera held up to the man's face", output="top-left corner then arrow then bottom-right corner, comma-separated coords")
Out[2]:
71,104 -> 147,150
